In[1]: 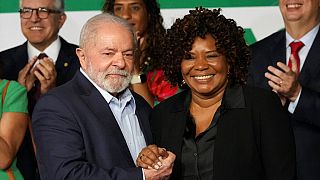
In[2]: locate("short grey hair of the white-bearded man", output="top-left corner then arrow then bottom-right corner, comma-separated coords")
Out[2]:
79,13 -> 138,57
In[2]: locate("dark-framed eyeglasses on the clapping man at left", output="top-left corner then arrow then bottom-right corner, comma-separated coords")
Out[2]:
19,7 -> 61,19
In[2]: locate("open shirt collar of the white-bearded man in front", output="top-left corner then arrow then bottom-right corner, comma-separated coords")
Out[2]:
80,68 -> 135,108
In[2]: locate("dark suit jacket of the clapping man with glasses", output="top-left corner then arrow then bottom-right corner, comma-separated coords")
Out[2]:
0,37 -> 80,180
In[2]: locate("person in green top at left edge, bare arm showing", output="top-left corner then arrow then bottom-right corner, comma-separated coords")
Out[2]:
0,64 -> 29,180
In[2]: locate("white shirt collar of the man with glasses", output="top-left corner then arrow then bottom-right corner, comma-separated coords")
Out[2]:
27,37 -> 61,64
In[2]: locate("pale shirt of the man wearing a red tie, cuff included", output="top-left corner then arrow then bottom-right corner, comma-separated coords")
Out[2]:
286,24 -> 320,114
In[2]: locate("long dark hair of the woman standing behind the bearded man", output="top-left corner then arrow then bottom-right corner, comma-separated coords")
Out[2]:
102,0 -> 166,72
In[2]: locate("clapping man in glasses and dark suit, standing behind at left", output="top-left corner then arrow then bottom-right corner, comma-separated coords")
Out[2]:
0,0 -> 80,180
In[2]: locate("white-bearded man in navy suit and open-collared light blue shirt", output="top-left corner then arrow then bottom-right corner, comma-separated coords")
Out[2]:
32,13 -> 175,180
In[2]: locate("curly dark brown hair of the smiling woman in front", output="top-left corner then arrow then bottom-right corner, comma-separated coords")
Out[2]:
161,7 -> 250,87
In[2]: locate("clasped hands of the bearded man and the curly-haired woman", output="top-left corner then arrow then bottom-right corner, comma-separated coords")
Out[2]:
136,145 -> 176,180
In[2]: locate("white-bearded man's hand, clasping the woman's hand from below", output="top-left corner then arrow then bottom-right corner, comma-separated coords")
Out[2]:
143,151 -> 176,180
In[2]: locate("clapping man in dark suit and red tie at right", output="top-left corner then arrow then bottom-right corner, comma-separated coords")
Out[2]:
248,0 -> 320,180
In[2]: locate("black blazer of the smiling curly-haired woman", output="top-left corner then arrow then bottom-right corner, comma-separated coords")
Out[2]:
150,86 -> 295,180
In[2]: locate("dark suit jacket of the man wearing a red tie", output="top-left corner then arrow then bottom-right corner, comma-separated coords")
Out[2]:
248,30 -> 320,180
